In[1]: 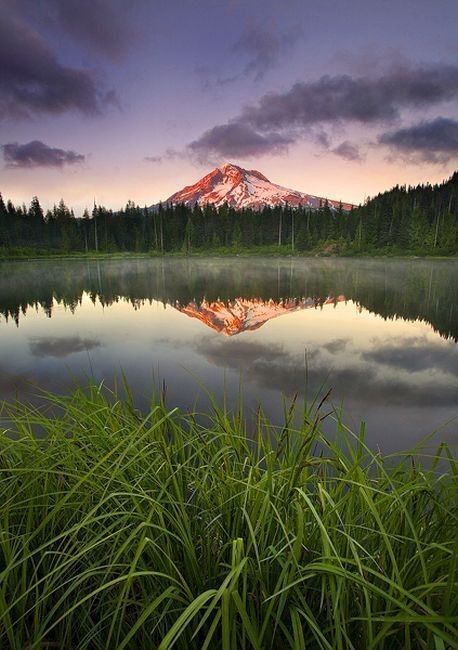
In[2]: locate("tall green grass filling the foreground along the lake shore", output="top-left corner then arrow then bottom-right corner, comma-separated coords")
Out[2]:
0,386 -> 458,650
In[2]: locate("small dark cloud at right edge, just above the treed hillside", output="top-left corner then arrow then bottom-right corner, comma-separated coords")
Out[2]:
378,117 -> 458,163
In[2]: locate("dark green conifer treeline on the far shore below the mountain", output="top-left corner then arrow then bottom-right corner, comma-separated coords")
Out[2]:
0,172 -> 458,254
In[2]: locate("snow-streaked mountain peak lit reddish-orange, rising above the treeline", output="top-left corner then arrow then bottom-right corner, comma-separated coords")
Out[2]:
161,163 -> 353,210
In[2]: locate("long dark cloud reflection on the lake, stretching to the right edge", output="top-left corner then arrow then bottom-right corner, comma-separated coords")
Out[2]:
196,338 -> 456,409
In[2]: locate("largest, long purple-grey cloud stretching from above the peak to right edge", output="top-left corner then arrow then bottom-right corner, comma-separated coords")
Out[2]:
188,64 -> 458,160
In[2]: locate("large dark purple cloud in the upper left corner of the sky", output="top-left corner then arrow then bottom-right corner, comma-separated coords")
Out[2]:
0,10 -> 112,119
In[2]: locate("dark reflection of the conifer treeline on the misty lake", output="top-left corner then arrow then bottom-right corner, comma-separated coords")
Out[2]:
0,258 -> 458,340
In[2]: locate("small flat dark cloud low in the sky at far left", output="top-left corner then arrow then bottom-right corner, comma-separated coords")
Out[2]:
2,140 -> 85,168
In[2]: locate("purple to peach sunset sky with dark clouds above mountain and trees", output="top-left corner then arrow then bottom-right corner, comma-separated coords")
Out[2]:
0,0 -> 458,216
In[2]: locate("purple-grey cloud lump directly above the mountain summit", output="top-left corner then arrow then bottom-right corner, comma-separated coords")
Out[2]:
187,122 -> 293,161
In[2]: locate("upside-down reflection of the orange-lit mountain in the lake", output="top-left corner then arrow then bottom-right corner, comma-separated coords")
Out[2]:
176,296 -> 345,336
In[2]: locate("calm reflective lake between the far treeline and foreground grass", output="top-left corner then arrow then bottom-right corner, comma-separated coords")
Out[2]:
0,257 -> 458,451
